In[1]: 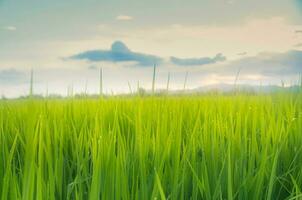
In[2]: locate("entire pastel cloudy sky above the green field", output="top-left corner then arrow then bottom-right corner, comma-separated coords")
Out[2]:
0,0 -> 302,97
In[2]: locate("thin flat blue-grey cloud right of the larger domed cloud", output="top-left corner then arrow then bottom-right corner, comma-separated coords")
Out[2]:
170,53 -> 226,66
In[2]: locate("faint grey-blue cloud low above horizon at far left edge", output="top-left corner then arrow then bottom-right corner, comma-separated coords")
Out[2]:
0,69 -> 26,84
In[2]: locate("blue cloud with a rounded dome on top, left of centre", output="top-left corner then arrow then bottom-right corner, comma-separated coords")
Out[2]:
70,41 -> 162,66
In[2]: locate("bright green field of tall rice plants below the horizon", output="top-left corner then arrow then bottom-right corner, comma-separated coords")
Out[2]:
0,92 -> 302,200
